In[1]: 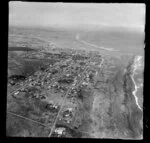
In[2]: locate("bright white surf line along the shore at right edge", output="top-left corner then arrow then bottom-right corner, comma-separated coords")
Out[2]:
131,56 -> 142,111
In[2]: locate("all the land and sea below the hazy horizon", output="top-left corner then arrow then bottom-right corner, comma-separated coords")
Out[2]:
6,27 -> 144,139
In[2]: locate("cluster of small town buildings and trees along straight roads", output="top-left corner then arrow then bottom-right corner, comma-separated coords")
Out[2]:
7,48 -> 103,137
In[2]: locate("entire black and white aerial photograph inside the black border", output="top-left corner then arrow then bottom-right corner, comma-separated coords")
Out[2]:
6,1 -> 146,140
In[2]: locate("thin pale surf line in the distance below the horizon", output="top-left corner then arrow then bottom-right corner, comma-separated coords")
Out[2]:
76,34 -> 119,51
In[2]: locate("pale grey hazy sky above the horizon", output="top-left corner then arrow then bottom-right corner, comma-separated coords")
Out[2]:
9,1 -> 145,31
